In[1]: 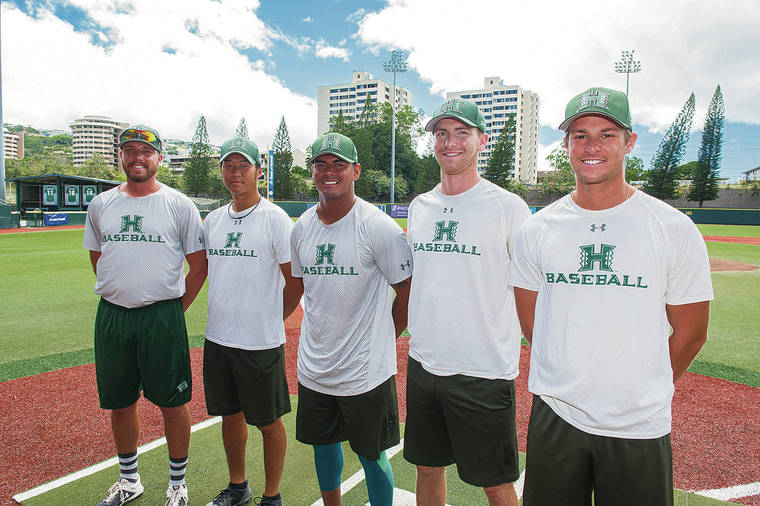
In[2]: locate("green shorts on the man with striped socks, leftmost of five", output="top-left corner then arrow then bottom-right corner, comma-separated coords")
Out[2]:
95,299 -> 192,409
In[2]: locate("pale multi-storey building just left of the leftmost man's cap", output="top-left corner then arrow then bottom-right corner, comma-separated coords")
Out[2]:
69,116 -> 129,167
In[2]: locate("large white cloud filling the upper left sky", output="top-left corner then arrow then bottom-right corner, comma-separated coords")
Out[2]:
2,0 -> 317,148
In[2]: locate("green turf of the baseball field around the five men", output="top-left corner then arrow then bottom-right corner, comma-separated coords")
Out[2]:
0,226 -> 760,505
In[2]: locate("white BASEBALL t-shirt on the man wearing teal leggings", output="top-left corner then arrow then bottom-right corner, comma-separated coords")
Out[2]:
290,198 -> 412,396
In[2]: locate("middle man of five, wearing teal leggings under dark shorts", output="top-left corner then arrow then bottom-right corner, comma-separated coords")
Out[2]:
290,133 -> 412,506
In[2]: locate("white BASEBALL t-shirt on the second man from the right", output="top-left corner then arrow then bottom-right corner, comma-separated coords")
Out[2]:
407,179 -> 530,379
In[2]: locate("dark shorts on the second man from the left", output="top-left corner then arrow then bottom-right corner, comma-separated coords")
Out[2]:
203,339 -> 290,426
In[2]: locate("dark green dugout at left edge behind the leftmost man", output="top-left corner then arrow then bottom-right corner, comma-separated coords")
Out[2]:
8,174 -> 120,227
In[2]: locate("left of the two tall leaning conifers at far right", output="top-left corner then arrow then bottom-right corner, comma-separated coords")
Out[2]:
644,92 -> 695,200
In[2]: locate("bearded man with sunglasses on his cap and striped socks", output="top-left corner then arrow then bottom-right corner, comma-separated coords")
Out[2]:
84,125 -> 207,506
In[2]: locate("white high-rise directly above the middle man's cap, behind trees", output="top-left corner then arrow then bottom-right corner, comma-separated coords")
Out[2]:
317,71 -> 412,135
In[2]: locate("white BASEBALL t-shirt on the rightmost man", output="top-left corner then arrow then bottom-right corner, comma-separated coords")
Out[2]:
509,191 -> 713,439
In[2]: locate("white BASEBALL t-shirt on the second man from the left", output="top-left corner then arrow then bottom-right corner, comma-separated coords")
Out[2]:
204,198 -> 293,350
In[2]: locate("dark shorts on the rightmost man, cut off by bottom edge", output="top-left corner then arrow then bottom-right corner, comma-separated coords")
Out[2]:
523,395 -> 673,506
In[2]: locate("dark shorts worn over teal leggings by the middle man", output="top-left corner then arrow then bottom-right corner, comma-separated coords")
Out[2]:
296,376 -> 401,460
